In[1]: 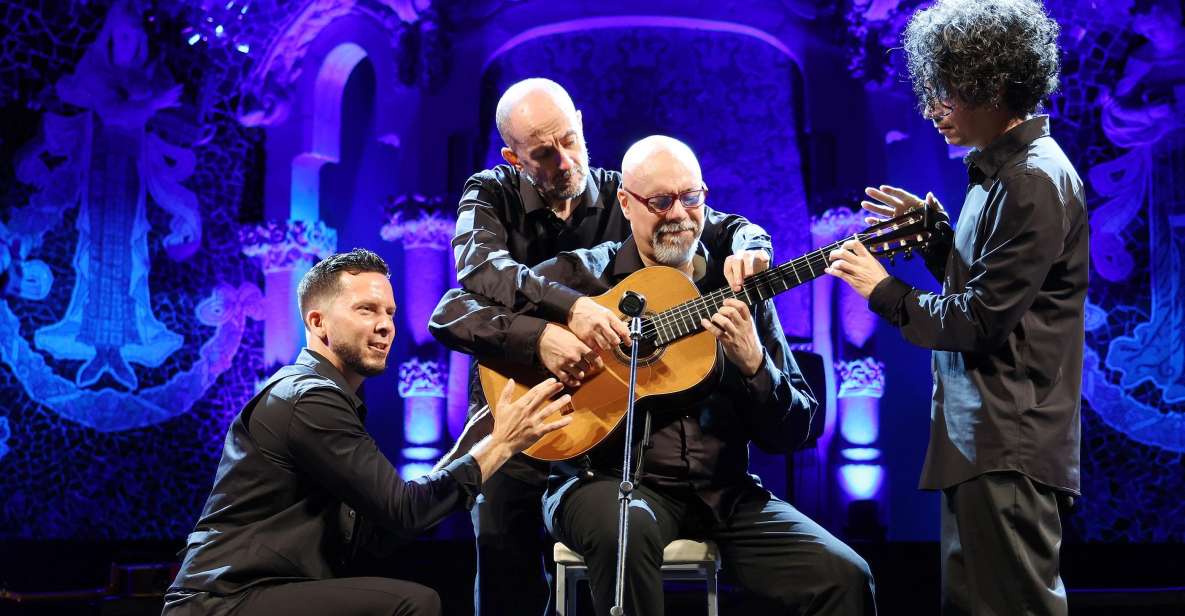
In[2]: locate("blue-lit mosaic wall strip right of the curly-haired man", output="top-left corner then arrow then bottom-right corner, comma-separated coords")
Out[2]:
1051,1 -> 1185,541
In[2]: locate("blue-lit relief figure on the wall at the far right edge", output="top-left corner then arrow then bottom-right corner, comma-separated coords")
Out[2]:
1083,4 -> 1185,451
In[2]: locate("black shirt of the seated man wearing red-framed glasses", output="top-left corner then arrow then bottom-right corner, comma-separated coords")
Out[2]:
536,238 -> 816,520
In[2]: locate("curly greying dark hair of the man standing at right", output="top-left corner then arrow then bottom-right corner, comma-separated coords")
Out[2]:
904,0 -> 1061,117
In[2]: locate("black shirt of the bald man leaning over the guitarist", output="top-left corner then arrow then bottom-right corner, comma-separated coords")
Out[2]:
428,165 -> 773,486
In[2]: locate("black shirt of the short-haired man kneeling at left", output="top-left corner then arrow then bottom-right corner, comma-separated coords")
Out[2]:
172,348 -> 481,595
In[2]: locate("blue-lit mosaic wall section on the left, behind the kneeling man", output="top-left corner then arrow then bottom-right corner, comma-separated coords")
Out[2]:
0,4 -> 262,539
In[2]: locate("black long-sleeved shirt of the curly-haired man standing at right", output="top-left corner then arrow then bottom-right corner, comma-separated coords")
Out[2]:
869,116 -> 1089,493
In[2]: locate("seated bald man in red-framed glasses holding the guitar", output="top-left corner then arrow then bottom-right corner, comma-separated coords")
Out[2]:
434,136 -> 876,615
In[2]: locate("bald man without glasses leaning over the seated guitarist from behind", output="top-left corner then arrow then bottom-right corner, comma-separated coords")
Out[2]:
429,78 -> 771,616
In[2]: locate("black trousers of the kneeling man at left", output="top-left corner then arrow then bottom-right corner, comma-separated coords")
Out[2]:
161,577 -> 441,616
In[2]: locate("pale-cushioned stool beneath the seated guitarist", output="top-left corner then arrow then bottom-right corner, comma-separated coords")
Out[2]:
555,539 -> 720,616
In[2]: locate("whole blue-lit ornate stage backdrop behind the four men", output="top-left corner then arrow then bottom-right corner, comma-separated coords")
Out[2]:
0,0 -> 1185,614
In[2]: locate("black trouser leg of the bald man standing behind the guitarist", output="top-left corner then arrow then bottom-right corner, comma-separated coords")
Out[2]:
469,473 -> 552,616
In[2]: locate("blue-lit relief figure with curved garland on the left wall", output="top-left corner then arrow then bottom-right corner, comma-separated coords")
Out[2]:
0,2 -> 262,431
